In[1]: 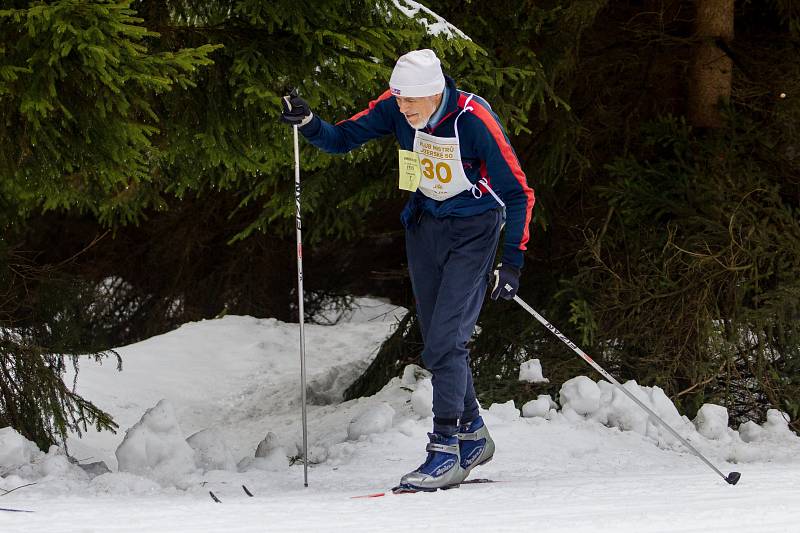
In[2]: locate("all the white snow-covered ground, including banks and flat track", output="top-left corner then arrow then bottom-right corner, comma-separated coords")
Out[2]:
0,299 -> 800,533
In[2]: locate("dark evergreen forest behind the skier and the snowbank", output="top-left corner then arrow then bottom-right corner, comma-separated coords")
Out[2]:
0,0 -> 800,447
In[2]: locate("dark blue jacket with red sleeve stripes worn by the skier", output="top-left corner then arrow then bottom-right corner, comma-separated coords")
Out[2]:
300,77 -> 535,267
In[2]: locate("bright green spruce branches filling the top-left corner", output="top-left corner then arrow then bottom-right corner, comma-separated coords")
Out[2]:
0,0 -> 220,222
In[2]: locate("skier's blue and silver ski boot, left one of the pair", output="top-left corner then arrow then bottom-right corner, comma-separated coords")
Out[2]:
392,433 -> 466,493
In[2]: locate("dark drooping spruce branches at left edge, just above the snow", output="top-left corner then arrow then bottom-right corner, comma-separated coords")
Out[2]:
0,241 -> 121,450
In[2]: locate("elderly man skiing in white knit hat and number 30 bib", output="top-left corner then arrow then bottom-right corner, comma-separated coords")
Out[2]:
281,49 -> 534,491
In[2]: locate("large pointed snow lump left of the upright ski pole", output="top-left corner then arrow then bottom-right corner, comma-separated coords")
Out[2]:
116,400 -> 197,487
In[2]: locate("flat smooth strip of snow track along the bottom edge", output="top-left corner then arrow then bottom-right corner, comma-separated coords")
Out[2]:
0,465 -> 800,533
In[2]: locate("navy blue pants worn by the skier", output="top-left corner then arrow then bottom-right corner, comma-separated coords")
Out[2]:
406,209 -> 502,432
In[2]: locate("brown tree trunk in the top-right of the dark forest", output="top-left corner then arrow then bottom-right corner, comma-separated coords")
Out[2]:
689,0 -> 734,128
